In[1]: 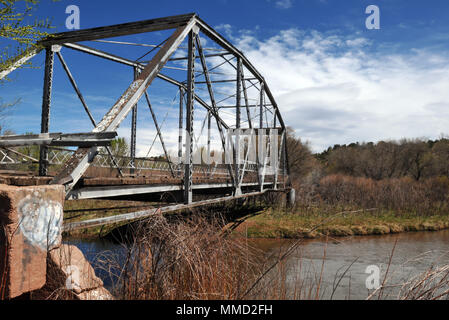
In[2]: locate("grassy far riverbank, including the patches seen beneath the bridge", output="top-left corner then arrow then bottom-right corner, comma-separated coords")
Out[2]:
64,200 -> 449,239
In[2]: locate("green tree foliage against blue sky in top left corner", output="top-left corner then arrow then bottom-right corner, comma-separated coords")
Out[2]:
0,0 -> 52,79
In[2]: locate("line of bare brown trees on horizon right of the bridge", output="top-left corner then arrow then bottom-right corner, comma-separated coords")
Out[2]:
287,129 -> 449,181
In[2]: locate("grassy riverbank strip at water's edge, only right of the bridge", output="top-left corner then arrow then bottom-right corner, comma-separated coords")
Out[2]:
234,208 -> 449,239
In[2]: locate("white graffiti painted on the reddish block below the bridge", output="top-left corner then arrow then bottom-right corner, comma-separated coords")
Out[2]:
18,194 -> 63,250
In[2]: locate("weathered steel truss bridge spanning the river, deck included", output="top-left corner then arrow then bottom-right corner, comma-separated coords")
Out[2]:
0,14 -> 290,227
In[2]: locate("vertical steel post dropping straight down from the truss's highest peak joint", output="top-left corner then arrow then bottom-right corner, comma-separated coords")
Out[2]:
184,27 -> 199,204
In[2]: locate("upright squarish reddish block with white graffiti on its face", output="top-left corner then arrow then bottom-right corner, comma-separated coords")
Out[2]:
0,185 -> 64,299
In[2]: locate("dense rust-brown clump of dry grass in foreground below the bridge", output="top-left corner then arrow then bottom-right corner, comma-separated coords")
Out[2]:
99,215 -> 268,300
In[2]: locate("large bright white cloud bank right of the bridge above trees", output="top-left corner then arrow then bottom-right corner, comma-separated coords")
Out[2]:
222,29 -> 449,151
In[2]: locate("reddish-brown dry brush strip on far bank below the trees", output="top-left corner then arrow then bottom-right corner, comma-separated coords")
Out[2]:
296,174 -> 449,215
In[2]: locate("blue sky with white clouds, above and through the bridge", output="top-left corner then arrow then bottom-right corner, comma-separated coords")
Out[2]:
0,0 -> 449,155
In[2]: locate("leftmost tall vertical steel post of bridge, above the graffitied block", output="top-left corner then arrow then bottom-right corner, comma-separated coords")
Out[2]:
39,47 -> 55,176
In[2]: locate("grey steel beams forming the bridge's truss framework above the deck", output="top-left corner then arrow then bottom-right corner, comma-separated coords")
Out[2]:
0,13 -> 290,212
